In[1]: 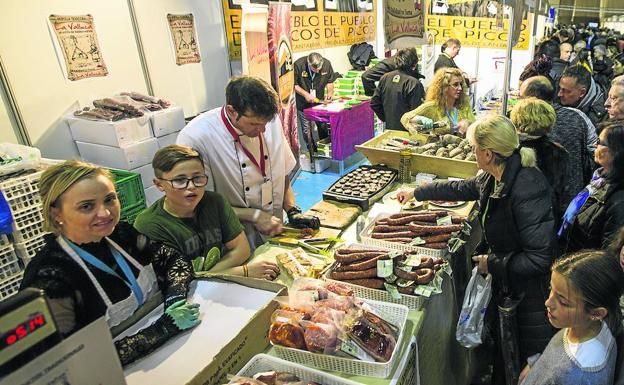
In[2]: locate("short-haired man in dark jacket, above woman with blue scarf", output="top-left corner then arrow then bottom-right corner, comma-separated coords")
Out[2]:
557,65 -> 607,126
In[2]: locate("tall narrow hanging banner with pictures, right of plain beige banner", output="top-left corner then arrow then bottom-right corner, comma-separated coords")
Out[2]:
267,2 -> 299,159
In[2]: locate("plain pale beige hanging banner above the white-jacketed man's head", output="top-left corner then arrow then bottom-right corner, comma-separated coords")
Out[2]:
241,4 -> 271,83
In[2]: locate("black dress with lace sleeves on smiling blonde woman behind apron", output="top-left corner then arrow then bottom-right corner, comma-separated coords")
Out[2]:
20,222 -> 193,365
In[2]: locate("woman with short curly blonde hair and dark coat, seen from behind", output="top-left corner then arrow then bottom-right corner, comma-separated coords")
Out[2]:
511,98 -> 581,220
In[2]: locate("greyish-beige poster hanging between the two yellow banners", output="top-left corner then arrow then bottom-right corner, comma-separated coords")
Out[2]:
383,0 -> 425,49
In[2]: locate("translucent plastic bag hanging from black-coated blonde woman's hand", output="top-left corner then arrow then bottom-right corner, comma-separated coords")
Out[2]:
455,266 -> 492,348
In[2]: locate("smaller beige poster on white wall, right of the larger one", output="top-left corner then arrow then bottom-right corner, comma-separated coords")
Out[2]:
167,13 -> 201,66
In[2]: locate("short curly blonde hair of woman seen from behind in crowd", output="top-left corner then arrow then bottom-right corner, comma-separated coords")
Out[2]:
511,98 -> 557,136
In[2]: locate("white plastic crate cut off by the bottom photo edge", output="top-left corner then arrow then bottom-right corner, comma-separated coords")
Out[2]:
237,354 -> 360,385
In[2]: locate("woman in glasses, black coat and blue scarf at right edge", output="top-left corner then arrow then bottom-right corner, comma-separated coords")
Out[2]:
559,120 -> 624,252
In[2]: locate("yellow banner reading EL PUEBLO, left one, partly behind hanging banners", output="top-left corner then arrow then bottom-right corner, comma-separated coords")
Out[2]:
223,0 -> 377,60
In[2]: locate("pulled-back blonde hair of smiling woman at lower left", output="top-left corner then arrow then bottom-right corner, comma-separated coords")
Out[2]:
39,160 -> 114,235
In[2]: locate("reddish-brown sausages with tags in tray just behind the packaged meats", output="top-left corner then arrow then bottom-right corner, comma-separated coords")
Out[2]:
329,243 -> 446,294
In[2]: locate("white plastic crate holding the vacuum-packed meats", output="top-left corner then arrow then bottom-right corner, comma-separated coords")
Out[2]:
273,300 -> 409,378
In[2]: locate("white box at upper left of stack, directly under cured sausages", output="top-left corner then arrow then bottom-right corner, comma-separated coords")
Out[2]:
65,115 -> 153,147
